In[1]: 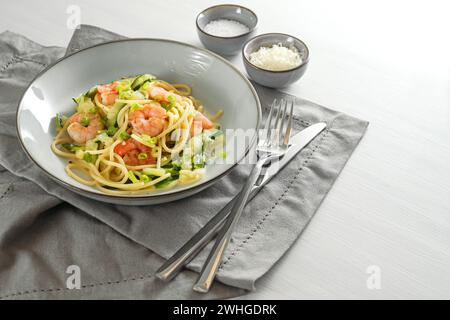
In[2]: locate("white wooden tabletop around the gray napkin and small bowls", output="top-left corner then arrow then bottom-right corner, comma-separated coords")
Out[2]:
0,0 -> 450,299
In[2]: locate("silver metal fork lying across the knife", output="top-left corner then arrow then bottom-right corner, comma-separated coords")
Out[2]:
193,100 -> 294,293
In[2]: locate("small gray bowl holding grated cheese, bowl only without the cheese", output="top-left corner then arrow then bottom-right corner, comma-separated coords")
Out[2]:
242,33 -> 309,88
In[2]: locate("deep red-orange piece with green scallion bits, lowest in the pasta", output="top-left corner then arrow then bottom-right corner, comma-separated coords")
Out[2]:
114,139 -> 156,166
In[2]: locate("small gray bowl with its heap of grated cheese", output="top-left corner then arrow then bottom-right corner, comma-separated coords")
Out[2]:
242,33 -> 309,88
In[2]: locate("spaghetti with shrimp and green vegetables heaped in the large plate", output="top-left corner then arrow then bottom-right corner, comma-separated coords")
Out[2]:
51,74 -> 224,195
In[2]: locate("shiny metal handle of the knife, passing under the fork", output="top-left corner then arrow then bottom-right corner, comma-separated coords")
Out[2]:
155,186 -> 262,281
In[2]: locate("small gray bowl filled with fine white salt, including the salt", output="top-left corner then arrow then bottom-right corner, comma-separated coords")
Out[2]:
196,4 -> 258,56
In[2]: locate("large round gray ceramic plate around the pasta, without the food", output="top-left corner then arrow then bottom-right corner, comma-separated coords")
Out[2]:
17,39 -> 261,205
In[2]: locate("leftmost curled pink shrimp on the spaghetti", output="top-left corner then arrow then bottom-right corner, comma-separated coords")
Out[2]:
67,113 -> 104,143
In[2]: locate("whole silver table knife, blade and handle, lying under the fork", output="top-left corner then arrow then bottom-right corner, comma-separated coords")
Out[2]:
155,122 -> 326,281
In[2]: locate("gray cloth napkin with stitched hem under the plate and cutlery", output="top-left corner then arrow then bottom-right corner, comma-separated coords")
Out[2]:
0,25 -> 368,298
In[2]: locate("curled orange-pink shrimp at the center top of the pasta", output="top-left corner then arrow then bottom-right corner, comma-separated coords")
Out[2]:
128,103 -> 166,137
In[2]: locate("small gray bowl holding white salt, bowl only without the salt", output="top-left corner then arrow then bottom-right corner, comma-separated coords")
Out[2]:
196,4 -> 258,56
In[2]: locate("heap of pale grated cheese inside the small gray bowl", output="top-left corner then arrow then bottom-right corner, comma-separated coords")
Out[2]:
250,43 -> 302,71
